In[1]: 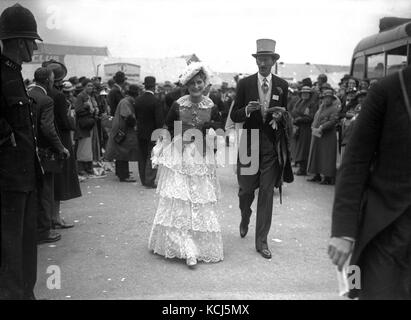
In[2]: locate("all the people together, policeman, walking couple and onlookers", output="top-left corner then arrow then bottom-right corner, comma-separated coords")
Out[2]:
0,4 -> 411,299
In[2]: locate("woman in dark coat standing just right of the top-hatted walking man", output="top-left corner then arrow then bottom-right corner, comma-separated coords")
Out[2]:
291,86 -> 318,176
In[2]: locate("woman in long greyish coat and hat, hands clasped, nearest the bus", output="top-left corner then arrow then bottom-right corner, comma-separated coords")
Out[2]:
308,89 -> 338,184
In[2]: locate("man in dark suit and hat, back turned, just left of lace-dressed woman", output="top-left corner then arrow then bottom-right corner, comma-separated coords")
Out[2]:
135,77 -> 164,188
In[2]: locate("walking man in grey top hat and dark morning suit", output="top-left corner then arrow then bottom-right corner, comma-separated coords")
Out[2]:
231,39 -> 293,259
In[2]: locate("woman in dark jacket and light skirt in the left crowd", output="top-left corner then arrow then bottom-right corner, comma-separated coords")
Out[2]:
74,79 -> 101,175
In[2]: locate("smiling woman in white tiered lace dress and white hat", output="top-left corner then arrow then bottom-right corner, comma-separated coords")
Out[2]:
149,63 -> 224,267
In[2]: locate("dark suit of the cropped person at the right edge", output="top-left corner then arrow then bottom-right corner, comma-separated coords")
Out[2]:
331,67 -> 411,299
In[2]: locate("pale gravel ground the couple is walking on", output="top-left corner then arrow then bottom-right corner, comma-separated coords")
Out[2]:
36,163 -> 340,300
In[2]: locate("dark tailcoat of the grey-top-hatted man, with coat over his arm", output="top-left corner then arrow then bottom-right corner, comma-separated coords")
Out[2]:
230,73 -> 294,187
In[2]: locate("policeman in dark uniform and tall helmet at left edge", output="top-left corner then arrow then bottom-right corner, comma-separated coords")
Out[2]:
0,4 -> 42,299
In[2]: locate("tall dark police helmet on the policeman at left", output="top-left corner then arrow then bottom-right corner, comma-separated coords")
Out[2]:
0,3 -> 43,41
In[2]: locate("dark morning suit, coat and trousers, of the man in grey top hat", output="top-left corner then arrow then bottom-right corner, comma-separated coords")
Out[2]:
231,74 -> 293,250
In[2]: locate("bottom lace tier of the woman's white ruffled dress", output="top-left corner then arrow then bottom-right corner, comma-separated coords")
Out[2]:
148,224 -> 224,263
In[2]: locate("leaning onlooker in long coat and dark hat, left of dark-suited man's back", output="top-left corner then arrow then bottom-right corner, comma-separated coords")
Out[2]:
104,85 -> 140,182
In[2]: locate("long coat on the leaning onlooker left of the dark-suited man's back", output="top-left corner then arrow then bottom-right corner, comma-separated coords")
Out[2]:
104,96 -> 140,161
